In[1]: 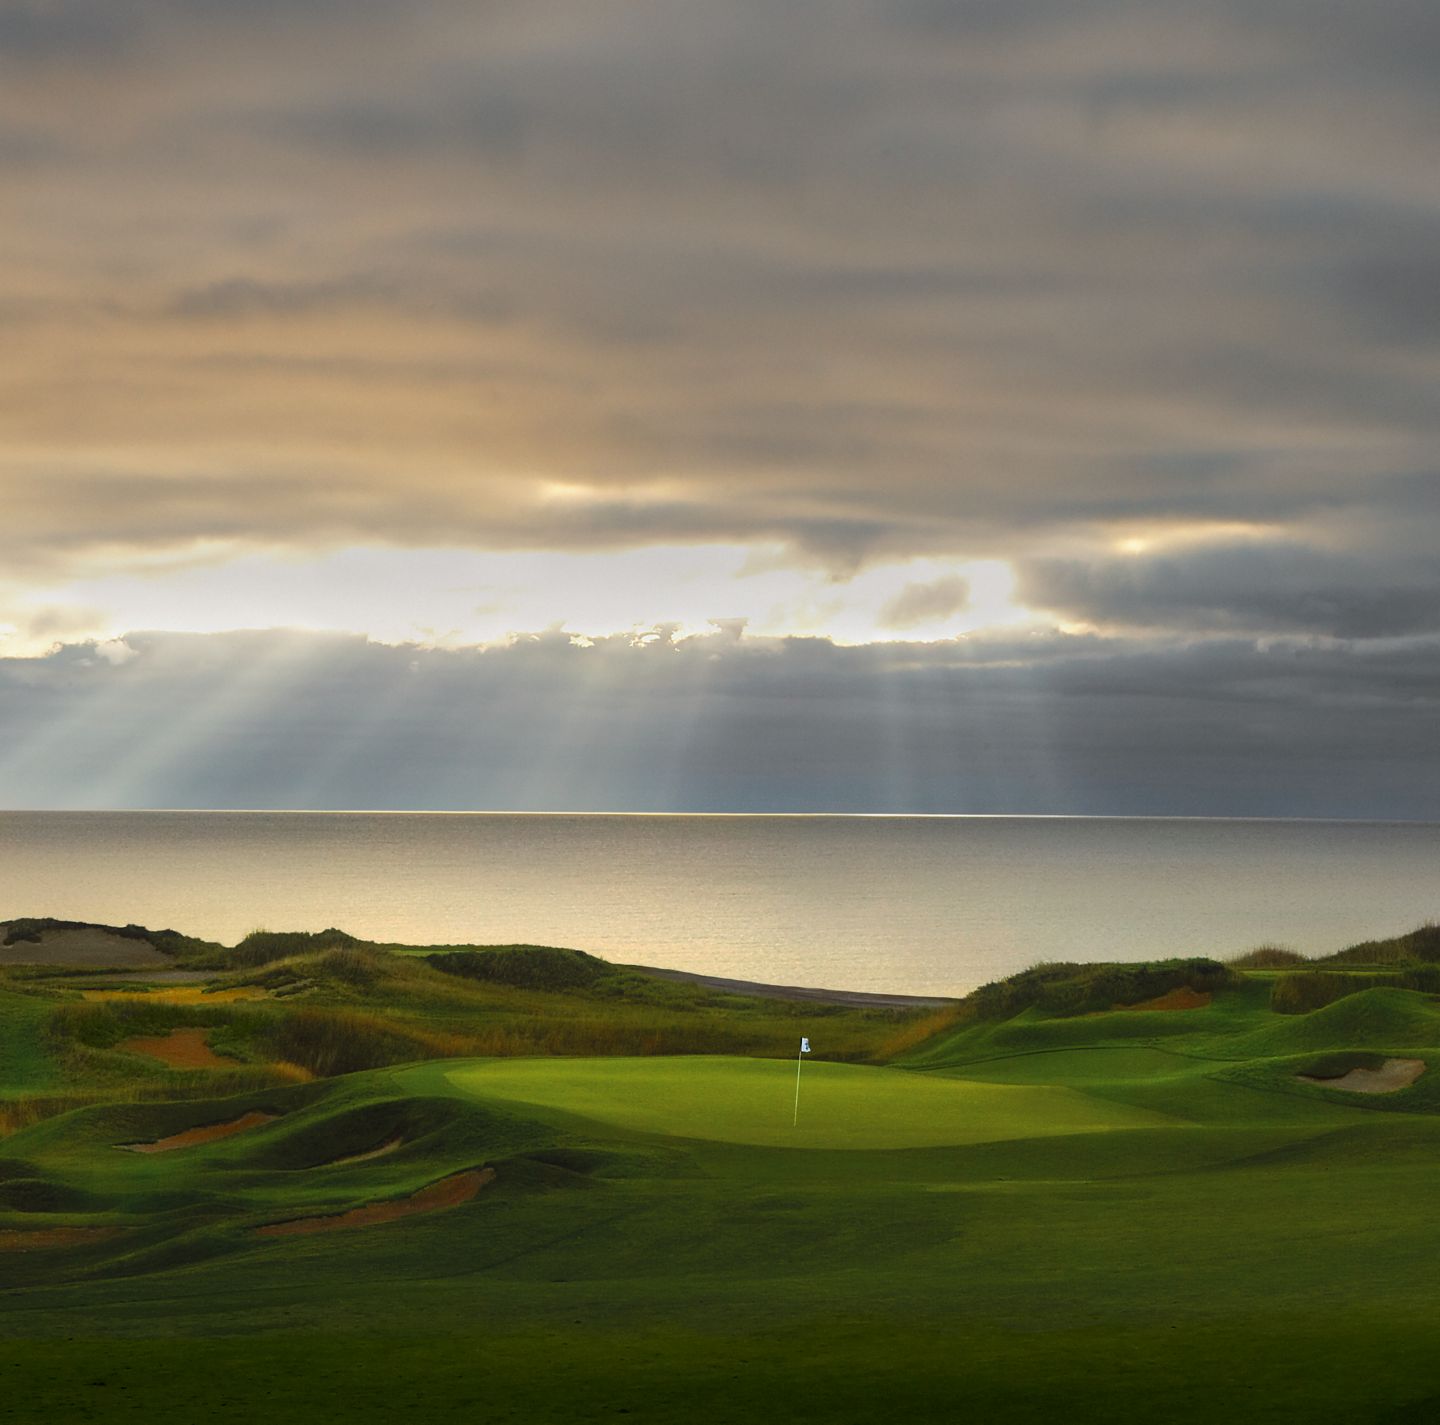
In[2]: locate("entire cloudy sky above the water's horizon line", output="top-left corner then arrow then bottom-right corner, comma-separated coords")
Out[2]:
0,0 -> 1440,819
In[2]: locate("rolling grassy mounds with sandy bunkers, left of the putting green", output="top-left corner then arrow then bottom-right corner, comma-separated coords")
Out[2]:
0,1074 -> 584,1284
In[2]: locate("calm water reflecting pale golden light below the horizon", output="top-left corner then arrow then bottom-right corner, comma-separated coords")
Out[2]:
0,812 -> 1440,995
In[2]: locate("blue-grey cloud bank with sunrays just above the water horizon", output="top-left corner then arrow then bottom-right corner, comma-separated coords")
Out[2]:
0,629 -> 1440,818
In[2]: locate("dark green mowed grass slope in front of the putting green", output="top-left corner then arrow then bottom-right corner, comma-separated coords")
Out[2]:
8,1064 -> 1440,1422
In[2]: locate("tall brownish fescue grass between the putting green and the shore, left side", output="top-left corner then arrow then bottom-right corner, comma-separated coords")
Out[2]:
36,946 -> 933,1097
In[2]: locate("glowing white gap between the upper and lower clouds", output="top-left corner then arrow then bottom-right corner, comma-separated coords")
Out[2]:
0,544 -> 1031,656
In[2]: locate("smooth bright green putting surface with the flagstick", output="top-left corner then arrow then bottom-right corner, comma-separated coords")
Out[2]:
445,1057 -> 1175,1149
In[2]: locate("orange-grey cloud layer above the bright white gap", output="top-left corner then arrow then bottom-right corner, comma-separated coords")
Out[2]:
0,0 -> 1440,636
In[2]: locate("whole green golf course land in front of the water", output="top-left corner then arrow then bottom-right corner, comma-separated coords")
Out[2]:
0,937 -> 1440,1425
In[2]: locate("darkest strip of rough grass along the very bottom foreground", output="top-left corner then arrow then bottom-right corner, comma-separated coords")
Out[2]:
8,1310 -> 1440,1425
